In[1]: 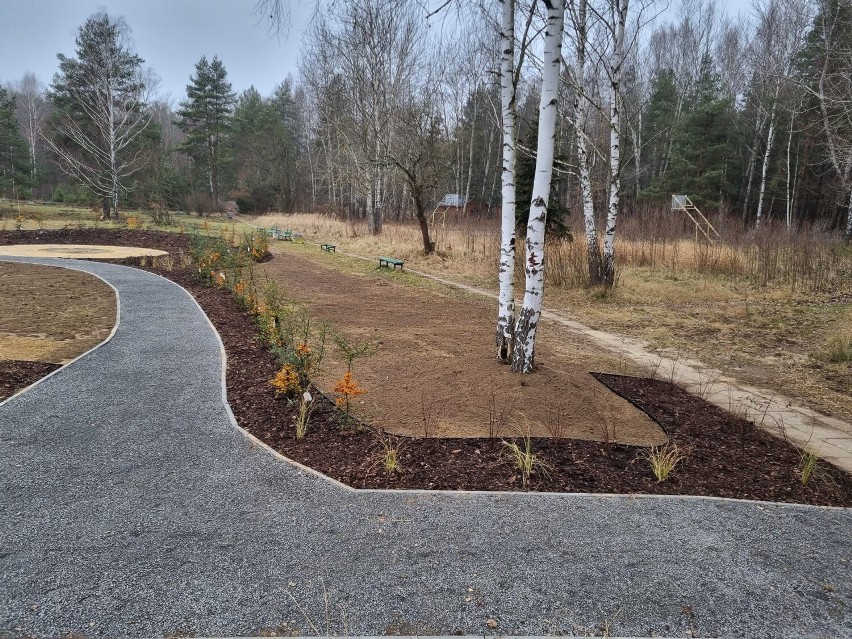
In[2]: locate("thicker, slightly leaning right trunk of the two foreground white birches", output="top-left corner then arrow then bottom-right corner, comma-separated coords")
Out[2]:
512,0 -> 565,373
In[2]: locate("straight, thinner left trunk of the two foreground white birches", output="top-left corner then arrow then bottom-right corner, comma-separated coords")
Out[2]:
496,0 -> 515,363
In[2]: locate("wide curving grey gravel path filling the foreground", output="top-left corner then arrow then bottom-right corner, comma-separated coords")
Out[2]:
0,260 -> 852,639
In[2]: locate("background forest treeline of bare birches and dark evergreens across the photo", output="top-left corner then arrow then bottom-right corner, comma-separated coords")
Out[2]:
0,0 -> 852,232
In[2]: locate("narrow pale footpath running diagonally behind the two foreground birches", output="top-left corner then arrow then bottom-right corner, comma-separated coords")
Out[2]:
344,253 -> 852,473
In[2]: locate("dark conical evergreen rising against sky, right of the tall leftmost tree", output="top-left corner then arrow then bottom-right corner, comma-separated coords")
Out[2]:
177,56 -> 236,208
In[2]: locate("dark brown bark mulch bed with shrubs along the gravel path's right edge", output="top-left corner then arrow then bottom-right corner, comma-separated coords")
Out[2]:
0,229 -> 852,507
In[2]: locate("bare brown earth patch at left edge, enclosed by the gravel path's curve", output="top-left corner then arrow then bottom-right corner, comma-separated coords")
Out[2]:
0,261 -> 117,364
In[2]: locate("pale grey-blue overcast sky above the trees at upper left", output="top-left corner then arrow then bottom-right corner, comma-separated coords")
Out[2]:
0,0 -> 749,104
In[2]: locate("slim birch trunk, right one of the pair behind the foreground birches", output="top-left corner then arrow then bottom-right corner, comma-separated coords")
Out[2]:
603,0 -> 629,288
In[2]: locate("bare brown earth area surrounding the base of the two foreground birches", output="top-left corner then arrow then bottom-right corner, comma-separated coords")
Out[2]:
260,245 -> 666,446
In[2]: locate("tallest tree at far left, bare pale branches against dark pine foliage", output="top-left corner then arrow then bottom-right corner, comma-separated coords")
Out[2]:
46,11 -> 151,218
